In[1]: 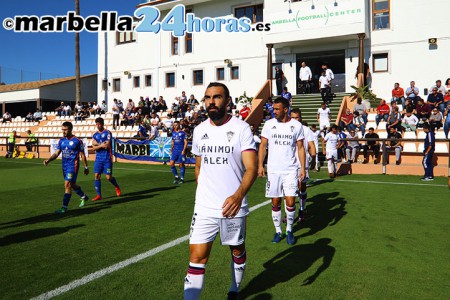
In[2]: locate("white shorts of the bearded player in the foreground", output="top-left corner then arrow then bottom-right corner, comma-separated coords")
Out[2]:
189,213 -> 247,246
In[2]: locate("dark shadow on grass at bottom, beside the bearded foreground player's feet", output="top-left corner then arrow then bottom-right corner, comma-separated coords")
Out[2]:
243,238 -> 336,299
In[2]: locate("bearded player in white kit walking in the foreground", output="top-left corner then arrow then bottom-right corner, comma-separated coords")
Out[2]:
184,82 -> 257,299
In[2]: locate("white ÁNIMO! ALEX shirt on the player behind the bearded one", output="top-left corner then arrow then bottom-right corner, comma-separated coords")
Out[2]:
261,118 -> 305,173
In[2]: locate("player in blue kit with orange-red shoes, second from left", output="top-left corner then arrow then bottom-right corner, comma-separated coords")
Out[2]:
92,118 -> 121,201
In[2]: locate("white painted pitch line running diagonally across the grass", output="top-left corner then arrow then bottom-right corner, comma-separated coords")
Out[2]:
31,200 -> 272,300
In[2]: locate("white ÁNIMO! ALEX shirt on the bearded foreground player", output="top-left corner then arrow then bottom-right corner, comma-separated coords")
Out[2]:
192,116 -> 256,218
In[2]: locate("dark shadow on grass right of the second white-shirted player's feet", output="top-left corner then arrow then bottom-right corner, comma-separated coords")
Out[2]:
294,192 -> 347,237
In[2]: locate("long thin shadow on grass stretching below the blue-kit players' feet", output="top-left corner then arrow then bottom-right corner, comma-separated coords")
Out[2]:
0,186 -> 177,230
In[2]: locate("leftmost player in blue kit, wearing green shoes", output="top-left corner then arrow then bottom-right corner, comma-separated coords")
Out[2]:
44,122 -> 89,214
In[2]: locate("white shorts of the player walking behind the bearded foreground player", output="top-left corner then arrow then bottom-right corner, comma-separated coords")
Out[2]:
266,170 -> 299,198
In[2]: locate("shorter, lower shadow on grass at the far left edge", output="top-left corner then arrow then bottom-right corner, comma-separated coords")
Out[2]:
0,224 -> 85,247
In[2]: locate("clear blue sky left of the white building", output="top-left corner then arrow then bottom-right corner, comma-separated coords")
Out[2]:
0,0 -> 144,84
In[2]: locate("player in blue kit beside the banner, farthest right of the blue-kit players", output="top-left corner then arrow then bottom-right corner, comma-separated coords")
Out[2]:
169,121 -> 187,184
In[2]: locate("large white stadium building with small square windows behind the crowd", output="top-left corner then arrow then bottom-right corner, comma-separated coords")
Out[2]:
98,0 -> 450,105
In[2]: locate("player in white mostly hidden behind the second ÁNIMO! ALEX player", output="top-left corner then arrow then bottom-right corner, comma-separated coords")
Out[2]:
291,108 -> 317,222
